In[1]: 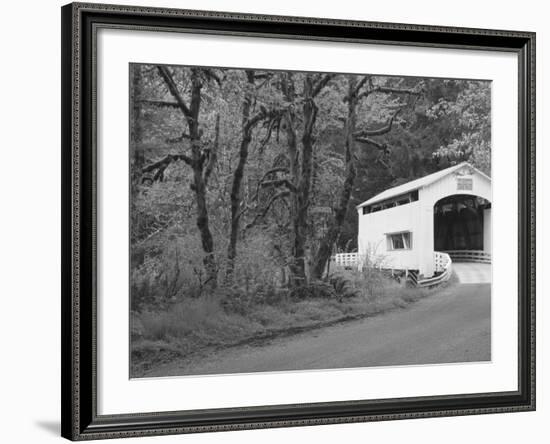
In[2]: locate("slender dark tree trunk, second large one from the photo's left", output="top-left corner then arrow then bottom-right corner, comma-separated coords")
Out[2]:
225,71 -> 254,283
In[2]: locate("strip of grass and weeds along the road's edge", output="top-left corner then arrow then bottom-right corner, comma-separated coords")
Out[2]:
131,271 -> 455,377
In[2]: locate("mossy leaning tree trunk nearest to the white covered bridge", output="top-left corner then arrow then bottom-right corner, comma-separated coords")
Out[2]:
312,76 -> 357,279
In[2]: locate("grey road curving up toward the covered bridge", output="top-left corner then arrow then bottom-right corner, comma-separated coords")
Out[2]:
144,284 -> 491,376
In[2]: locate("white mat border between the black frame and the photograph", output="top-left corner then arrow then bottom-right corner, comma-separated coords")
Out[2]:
97,29 -> 518,414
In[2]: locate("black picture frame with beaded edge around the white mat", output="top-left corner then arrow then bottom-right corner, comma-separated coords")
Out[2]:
61,3 -> 535,440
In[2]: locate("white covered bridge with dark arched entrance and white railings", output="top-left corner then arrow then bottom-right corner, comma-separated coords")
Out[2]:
335,163 -> 492,285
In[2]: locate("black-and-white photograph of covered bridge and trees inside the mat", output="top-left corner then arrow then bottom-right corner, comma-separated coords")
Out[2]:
127,63 -> 493,378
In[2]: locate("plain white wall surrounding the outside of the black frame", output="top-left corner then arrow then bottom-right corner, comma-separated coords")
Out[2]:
0,0 -> 550,443
